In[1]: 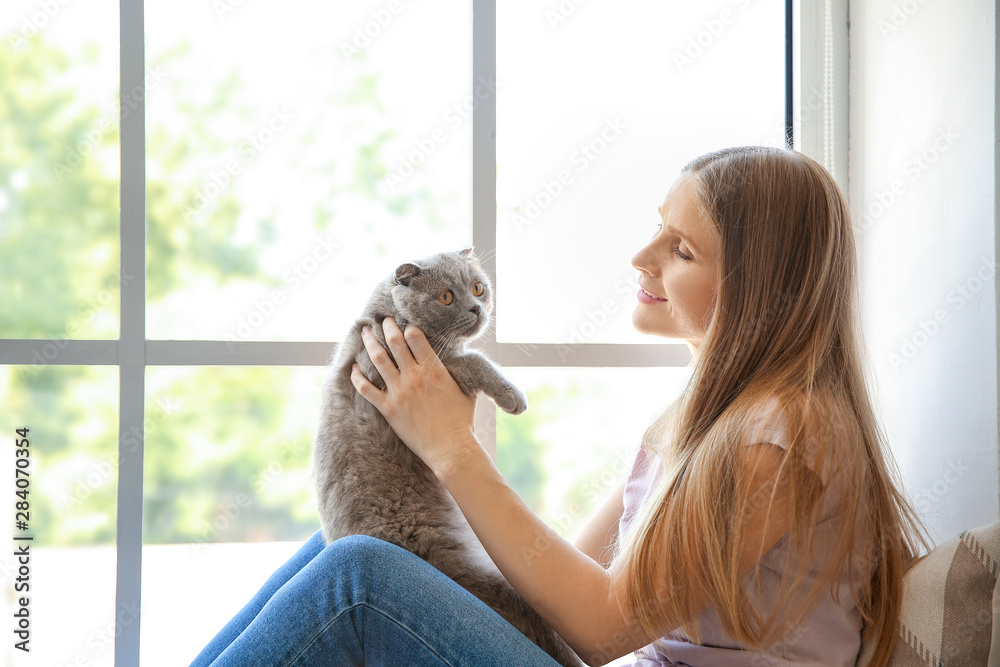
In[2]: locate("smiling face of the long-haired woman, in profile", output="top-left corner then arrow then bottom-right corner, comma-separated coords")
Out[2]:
632,176 -> 721,351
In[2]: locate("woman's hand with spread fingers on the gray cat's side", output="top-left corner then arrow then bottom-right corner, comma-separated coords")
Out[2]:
351,317 -> 476,474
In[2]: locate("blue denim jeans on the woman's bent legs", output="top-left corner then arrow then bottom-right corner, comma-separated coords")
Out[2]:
192,532 -> 558,667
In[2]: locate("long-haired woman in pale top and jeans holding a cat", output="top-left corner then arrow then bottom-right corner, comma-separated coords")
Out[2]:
195,147 -> 927,667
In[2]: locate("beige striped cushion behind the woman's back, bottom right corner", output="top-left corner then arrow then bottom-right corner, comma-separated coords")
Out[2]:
857,522 -> 1000,667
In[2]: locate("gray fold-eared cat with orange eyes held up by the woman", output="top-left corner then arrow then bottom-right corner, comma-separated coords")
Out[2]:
313,248 -> 580,665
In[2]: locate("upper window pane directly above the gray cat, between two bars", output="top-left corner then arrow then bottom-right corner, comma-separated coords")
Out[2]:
146,0 -> 475,340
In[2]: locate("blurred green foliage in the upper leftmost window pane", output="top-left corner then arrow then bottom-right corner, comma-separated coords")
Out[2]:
0,39 -> 118,338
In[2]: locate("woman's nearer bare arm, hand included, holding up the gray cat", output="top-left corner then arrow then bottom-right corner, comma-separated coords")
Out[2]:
351,319 -> 789,665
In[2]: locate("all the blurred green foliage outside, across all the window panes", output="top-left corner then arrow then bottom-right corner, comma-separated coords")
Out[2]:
0,37 -> 544,545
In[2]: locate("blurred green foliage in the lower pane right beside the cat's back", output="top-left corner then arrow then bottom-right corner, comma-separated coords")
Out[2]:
143,366 -> 317,542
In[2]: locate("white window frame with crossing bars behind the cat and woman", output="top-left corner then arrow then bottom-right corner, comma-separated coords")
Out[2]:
0,0 -> 816,667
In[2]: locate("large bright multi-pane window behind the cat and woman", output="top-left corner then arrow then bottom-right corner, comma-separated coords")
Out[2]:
0,0 -> 790,665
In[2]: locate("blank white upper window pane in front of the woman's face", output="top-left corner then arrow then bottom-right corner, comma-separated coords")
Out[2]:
497,0 -> 785,343
